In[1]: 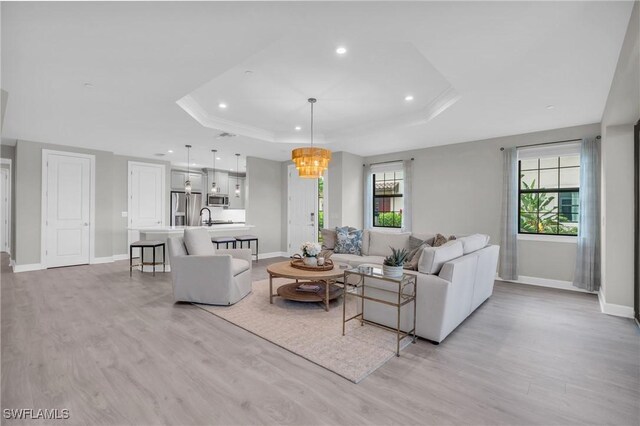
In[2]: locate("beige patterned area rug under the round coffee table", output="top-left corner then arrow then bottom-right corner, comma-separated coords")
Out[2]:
195,279 -> 411,383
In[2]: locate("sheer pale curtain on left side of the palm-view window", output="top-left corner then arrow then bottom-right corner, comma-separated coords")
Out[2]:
498,147 -> 520,280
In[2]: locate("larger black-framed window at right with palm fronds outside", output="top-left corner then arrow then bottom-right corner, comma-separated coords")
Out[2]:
518,154 -> 580,235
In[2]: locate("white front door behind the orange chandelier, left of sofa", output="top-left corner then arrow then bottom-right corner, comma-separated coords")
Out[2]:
287,165 -> 318,254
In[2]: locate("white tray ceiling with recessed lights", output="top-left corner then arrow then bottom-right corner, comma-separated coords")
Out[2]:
1,1 -> 633,168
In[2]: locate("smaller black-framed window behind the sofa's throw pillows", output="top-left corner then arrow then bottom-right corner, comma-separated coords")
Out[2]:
373,170 -> 404,228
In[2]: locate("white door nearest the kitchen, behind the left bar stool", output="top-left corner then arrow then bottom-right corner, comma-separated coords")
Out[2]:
128,161 -> 165,254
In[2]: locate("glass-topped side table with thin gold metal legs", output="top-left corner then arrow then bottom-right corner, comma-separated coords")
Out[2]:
342,265 -> 418,356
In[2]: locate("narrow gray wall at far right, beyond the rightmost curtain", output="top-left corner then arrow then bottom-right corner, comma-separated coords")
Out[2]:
601,2 -> 640,307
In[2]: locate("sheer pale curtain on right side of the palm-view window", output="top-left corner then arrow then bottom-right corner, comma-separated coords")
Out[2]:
573,139 -> 600,291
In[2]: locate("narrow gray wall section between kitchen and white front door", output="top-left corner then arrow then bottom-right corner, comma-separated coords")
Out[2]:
246,157 -> 286,253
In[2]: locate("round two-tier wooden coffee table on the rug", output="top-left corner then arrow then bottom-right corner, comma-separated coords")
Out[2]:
267,261 -> 348,311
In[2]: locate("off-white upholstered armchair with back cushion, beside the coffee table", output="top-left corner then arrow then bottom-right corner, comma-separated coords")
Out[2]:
168,229 -> 251,305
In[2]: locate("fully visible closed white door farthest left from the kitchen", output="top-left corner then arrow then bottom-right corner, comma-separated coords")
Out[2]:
43,150 -> 93,267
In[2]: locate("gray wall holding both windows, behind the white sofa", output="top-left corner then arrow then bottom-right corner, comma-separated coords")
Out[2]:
365,124 -> 600,281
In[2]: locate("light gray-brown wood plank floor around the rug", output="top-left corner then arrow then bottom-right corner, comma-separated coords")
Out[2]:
1,254 -> 640,425
